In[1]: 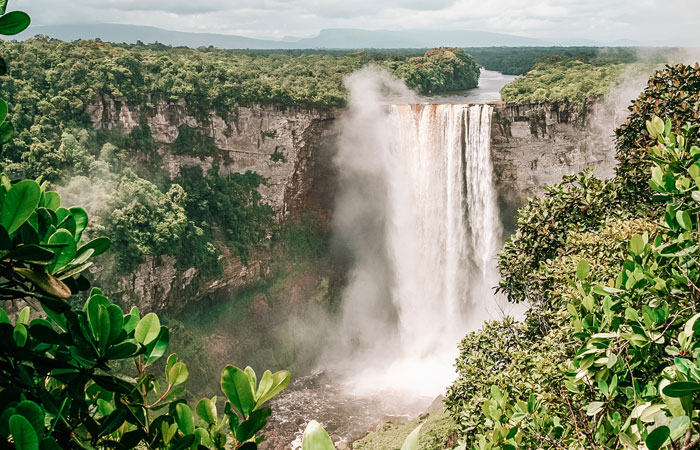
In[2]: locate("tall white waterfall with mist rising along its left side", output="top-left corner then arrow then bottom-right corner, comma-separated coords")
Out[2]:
331,67 -> 502,396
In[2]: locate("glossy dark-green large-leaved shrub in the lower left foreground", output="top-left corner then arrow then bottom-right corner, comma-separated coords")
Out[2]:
0,178 -> 290,450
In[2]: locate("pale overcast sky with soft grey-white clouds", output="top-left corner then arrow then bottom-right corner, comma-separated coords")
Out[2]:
9,0 -> 700,46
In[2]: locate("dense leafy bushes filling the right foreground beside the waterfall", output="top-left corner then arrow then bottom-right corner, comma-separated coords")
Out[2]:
446,65 -> 700,450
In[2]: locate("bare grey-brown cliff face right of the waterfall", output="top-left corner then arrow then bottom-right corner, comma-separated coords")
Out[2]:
491,101 -> 622,230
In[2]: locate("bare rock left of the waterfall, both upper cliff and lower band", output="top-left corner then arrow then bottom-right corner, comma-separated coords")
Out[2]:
89,96 -> 335,312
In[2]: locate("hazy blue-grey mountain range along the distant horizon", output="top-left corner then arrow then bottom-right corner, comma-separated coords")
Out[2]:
10,24 -> 636,49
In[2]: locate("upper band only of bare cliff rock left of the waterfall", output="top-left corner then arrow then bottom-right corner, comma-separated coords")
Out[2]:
88,96 -> 336,216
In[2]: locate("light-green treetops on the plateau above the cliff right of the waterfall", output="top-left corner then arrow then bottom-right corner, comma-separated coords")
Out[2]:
501,61 -> 624,105
